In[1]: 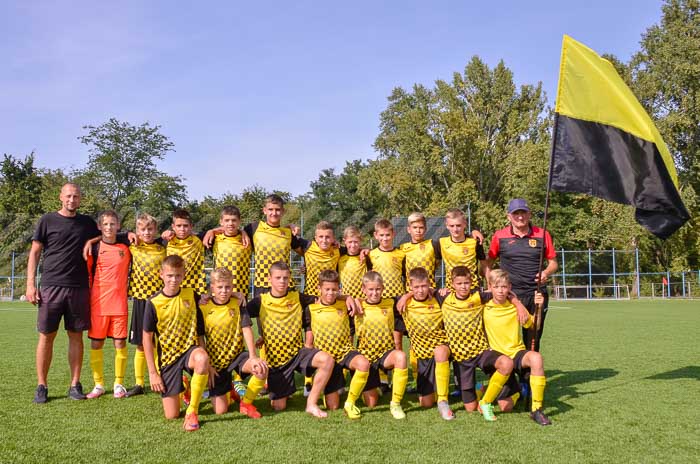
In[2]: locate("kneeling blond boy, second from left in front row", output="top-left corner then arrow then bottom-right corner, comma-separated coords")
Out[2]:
199,267 -> 267,419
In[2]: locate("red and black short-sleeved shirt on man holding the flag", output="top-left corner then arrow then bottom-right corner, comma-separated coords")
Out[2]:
489,225 -> 556,294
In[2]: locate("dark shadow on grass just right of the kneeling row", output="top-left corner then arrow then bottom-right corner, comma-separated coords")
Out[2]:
544,368 -> 619,416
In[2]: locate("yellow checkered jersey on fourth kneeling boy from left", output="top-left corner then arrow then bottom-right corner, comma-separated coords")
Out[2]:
305,300 -> 354,362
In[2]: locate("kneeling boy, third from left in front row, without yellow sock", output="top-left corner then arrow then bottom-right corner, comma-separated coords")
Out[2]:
247,261 -> 335,418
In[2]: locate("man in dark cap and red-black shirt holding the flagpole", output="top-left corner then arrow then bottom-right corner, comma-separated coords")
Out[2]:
485,198 -> 559,351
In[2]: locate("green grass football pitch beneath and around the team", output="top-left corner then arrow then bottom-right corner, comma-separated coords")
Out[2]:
0,300 -> 700,463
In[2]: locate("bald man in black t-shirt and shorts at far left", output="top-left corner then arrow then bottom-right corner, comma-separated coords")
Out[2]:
27,183 -> 100,403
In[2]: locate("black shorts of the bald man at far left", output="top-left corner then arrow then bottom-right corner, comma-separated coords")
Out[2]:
36,286 -> 90,334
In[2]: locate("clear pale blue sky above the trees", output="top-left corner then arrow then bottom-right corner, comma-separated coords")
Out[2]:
0,0 -> 661,199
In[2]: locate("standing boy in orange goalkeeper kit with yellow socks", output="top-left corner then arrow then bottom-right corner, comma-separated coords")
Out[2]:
87,211 -> 131,399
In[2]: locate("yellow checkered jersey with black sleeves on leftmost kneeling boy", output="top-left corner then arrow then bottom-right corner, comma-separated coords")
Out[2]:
143,288 -> 204,370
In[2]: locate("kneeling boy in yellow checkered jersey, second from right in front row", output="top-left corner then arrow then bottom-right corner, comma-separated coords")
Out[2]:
441,266 -> 513,421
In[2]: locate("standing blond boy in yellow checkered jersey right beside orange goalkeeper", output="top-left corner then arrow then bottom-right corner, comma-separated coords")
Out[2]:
126,213 -> 166,398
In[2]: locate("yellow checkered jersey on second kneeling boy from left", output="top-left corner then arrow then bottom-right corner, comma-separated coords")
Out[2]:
199,299 -> 251,371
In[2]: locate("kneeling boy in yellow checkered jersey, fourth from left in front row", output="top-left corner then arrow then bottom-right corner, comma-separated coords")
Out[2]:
304,270 -> 369,419
